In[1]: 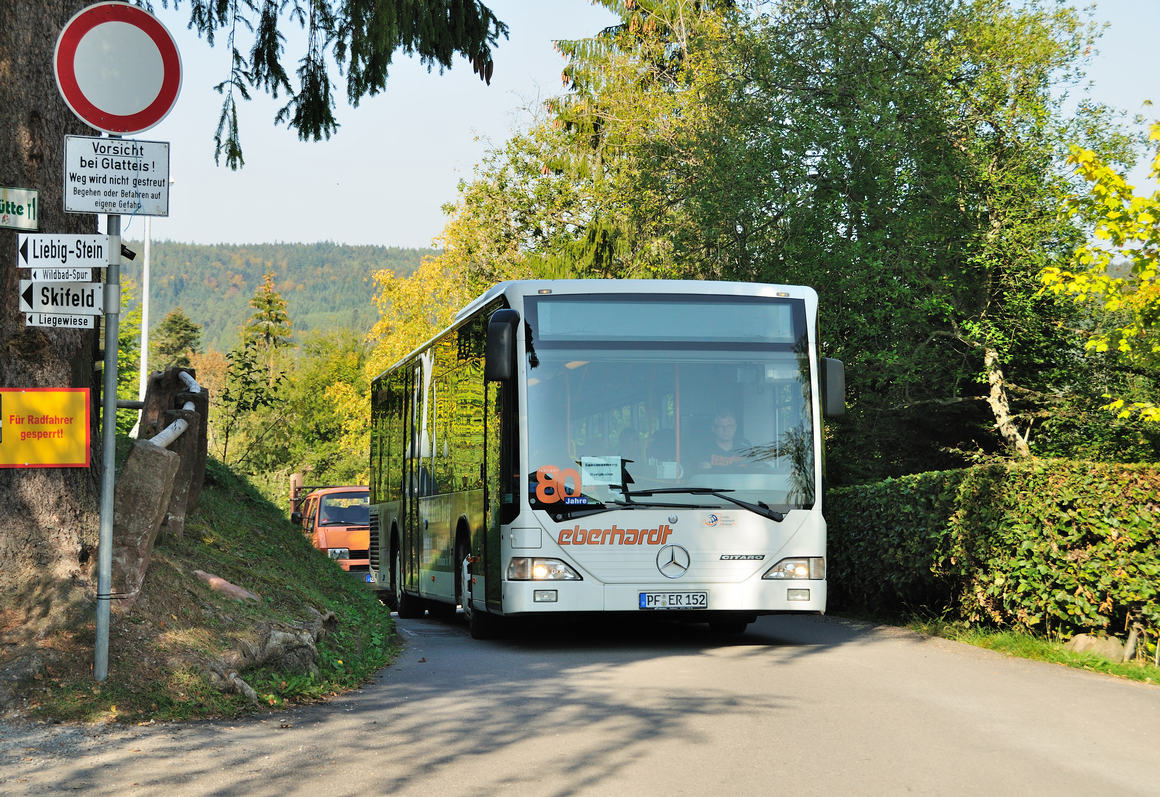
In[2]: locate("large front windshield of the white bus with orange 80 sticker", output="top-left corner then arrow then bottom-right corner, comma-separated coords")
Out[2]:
527,296 -> 815,515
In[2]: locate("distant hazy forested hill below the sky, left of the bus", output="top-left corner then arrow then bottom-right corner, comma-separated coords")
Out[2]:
122,241 -> 435,352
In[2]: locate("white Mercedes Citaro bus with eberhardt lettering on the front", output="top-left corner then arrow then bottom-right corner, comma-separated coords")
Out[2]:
370,280 -> 844,638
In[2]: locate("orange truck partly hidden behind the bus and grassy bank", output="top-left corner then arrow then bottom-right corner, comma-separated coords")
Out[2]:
290,485 -> 375,585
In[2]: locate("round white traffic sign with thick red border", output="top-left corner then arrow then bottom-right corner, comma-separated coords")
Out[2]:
52,2 -> 181,135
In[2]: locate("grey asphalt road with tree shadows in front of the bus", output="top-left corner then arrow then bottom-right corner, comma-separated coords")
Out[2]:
0,617 -> 1160,797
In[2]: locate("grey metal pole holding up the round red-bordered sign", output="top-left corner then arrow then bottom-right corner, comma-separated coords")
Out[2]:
93,196 -> 121,681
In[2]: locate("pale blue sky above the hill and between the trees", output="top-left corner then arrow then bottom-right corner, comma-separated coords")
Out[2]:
120,0 -> 1160,247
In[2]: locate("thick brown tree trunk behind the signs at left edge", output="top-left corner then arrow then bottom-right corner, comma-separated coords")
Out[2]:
0,0 -> 101,635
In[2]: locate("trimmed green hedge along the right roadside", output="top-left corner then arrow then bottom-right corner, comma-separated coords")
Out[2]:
826,459 -> 1160,637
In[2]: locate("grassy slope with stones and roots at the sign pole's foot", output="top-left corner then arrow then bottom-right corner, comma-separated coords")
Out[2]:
19,454 -> 394,722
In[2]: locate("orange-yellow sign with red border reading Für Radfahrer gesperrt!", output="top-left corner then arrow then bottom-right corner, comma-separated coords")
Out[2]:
0,387 -> 89,468
